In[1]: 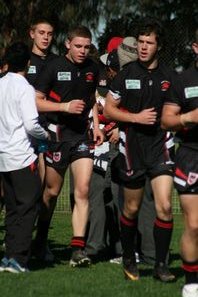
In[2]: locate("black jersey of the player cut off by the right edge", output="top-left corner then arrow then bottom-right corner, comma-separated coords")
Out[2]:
167,66 -> 198,149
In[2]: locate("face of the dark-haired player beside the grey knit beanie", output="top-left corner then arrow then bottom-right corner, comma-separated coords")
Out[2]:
137,33 -> 158,63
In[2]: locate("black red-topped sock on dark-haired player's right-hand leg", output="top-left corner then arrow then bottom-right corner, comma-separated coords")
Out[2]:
153,218 -> 173,265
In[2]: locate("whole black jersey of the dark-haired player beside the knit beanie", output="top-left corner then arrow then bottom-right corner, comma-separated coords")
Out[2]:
110,61 -> 176,169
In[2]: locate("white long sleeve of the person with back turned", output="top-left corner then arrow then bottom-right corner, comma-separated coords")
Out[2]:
20,85 -> 48,139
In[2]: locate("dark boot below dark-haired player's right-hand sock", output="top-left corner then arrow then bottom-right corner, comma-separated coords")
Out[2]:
153,263 -> 175,283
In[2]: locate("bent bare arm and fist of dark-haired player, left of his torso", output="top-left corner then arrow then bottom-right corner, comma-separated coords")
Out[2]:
104,92 -> 157,125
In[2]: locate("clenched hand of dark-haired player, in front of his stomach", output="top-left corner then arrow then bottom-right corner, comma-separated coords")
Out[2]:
133,107 -> 157,125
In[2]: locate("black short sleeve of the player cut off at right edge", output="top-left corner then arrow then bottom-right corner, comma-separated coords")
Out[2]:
164,72 -> 183,106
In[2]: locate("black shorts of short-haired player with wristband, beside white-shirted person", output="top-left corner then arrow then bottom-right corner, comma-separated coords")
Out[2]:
45,139 -> 94,169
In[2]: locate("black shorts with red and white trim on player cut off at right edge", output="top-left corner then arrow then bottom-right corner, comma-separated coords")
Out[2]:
174,146 -> 198,194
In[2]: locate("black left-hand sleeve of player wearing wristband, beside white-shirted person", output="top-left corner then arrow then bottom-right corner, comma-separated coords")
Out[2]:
35,60 -> 56,94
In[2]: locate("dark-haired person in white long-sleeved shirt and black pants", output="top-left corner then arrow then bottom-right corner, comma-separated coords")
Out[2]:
0,42 -> 48,273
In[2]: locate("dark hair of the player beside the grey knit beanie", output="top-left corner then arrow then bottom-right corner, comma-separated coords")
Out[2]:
137,18 -> 165,47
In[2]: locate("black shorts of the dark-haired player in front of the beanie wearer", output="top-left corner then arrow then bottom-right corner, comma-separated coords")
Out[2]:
111,153 -> 173,189
